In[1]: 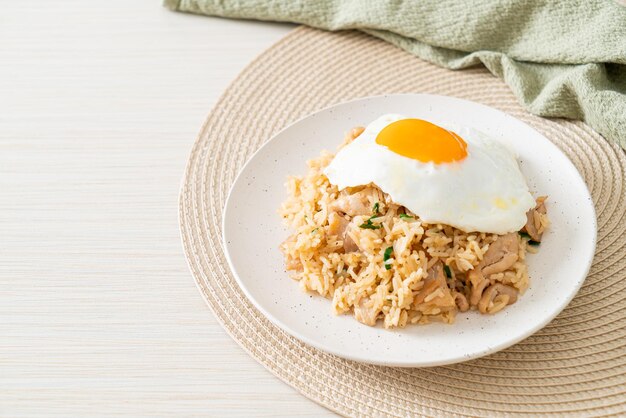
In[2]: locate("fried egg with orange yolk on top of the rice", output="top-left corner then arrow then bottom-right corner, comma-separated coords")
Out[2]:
324,115 -> 535,234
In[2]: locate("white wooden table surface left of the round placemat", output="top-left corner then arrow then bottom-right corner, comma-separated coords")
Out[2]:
0,0 -> 333,417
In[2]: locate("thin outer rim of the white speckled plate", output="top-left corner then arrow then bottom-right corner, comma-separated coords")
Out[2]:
221,93 -> 598,367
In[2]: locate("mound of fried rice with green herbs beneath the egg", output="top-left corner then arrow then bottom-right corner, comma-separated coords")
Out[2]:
280,131 -> 547,328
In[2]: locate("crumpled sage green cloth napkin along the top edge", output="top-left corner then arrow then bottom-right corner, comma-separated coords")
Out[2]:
165,0 -> 626,149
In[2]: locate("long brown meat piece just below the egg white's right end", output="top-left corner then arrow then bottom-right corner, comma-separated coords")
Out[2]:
468,232 -> 519,306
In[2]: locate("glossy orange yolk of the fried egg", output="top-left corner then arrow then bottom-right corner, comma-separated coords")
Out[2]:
376,119 -> 467,164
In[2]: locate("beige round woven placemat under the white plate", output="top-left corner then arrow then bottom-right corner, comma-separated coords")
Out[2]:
180,28 -> 626,417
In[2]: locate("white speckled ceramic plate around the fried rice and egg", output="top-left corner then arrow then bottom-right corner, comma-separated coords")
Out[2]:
223,94 -> 596,366
